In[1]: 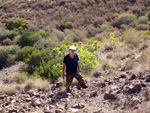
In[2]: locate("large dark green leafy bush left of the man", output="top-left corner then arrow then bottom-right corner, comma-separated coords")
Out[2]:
15,45 -> 62,82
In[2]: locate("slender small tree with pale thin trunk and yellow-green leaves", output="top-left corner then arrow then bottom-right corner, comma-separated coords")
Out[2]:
108,32 -> 122,64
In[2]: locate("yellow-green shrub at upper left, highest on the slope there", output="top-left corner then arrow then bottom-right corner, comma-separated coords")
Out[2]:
6,18 -> 27,31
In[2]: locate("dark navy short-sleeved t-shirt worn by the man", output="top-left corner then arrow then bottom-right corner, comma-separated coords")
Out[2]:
63,53 -> 79,74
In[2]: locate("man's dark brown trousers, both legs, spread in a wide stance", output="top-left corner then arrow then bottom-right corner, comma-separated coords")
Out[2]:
66,72 -> 86,90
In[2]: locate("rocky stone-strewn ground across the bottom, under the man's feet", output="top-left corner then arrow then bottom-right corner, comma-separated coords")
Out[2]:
0,67 -> 150,113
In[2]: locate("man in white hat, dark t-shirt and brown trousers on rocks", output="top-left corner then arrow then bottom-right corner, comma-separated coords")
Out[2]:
62,45 -> 87,91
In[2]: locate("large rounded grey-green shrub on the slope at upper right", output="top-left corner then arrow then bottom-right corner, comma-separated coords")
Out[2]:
117,13 -> 137,26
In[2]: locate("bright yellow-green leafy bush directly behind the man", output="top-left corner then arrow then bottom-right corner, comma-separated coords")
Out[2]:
52,40 -> 100,73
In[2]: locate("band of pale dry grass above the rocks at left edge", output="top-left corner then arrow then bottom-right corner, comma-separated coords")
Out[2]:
0,75 -> 50,95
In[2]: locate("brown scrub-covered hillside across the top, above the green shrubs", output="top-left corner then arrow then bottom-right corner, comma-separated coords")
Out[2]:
0,0 -> 150,29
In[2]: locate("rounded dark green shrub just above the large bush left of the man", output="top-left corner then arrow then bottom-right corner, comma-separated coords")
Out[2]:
18,32 -> 41,47
